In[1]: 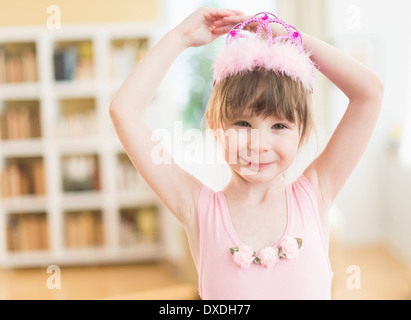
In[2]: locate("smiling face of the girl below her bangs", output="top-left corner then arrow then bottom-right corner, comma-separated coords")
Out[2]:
223,114 -> 300,183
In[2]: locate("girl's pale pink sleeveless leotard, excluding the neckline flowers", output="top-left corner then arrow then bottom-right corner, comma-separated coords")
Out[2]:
198,175 -> 333,300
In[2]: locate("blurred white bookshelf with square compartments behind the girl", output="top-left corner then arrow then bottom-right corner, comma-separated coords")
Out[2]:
0,23 -> 169,267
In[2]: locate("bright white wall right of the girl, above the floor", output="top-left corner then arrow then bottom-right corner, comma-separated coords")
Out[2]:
326,0 -> 411,261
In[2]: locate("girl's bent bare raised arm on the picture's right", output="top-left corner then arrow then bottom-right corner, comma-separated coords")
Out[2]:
302,34 -> 384,207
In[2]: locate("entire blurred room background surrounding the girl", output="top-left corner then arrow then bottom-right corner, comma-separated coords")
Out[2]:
0,0 -> 411,299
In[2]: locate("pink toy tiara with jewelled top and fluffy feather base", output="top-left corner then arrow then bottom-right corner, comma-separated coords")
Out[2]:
213,12 -> 314,92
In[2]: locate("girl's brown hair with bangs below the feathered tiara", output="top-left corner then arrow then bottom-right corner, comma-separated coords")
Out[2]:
206,69 -> 312,145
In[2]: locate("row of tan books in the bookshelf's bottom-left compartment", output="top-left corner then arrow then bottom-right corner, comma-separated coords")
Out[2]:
6,213 -> 49,251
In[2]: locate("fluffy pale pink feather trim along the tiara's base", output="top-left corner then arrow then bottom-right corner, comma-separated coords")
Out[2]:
213,39 -> 314,92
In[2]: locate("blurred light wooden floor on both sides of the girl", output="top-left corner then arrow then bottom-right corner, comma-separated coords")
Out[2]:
0,247 -> 411,300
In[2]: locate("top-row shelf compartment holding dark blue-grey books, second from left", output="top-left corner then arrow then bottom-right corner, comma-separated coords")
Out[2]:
53,40 -> 94,81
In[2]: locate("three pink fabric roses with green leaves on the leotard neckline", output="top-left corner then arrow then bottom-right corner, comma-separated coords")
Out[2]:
230,237 -> 303,268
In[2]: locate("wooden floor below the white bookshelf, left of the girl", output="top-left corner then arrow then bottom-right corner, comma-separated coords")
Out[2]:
0,263 -> 196,300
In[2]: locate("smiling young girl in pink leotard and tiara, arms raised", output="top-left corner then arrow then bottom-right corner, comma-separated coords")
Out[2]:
110,8 -> 383,299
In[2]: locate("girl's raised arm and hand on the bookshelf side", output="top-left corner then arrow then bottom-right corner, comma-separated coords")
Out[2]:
110,8 -> 245,226
